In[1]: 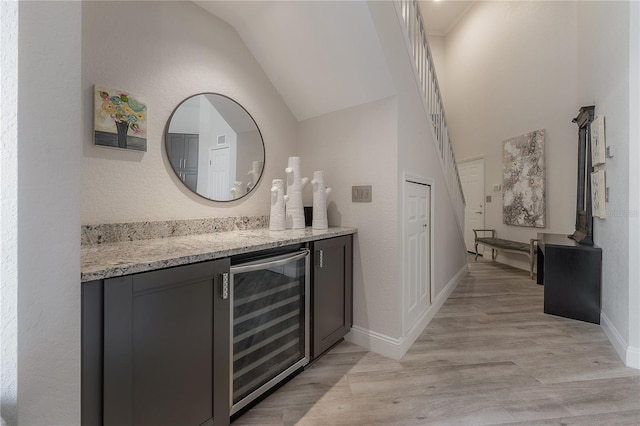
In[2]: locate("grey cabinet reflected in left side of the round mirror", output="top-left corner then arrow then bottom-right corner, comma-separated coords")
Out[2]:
167,133 -> 199,191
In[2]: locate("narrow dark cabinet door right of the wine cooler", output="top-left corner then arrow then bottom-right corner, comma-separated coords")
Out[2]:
312,235 -> 353,358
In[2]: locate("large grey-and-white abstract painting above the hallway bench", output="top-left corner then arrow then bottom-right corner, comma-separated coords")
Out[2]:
502,130 -> 545,228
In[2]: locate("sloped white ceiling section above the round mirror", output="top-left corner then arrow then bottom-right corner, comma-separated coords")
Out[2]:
195,1 -> 395,121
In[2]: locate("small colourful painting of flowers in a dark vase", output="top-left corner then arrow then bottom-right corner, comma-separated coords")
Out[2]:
93,86 -> 147,152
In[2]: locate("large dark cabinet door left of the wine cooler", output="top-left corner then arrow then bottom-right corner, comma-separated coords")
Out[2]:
103,259 -> 230,426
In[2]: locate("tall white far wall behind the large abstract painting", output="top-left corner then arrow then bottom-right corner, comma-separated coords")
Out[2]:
446,1 -> 580,269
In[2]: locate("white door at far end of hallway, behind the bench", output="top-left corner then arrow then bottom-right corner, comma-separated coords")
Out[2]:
458,158 -> 484,253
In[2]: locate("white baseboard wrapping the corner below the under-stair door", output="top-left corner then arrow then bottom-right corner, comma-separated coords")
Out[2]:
345,264 -> 469,360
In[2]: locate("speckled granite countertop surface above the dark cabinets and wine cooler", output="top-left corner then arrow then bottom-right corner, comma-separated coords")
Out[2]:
80,227 -> 357,282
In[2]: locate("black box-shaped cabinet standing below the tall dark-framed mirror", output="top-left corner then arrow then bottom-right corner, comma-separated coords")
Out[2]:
537,233 -> 602,324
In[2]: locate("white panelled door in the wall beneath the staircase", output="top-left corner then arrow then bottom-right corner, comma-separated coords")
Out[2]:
403,179 -> 431,335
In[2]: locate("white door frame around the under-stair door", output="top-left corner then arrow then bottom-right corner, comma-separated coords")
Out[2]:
400,172 -> 436,337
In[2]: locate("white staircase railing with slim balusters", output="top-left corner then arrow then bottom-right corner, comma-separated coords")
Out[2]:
394,0 -> 465,229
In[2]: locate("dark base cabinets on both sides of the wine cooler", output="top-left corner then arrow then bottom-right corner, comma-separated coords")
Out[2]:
81,235 -> 353,426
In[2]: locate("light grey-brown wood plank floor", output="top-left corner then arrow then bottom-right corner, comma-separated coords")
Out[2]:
233,261 -> 640,426
